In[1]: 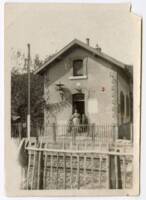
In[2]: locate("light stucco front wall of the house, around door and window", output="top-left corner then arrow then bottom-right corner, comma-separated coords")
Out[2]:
44,48 -> 127,134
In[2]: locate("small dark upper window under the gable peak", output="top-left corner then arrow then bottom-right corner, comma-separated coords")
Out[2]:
73,59 -> 83,76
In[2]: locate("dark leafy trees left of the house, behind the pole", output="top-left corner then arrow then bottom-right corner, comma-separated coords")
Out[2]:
11,52 -> 43,125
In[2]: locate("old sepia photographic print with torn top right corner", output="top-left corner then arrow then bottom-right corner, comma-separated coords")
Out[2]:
5,3 -> 141,196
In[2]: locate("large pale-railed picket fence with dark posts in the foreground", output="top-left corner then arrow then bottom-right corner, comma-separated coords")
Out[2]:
22,140 -> 133,190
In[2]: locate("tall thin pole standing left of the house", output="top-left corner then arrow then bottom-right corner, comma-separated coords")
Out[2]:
27,44 -> 31,139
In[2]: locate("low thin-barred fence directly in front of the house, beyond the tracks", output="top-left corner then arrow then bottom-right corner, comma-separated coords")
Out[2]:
11,123 -> 133,143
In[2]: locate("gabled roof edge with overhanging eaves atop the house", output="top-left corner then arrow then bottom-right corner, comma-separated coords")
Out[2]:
34,39 -> 132,74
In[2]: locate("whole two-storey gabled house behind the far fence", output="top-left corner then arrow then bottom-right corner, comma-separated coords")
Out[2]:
35,39 -> 132,138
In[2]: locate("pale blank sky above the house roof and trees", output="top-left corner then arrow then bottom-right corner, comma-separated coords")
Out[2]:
5,3 -> 139,68
